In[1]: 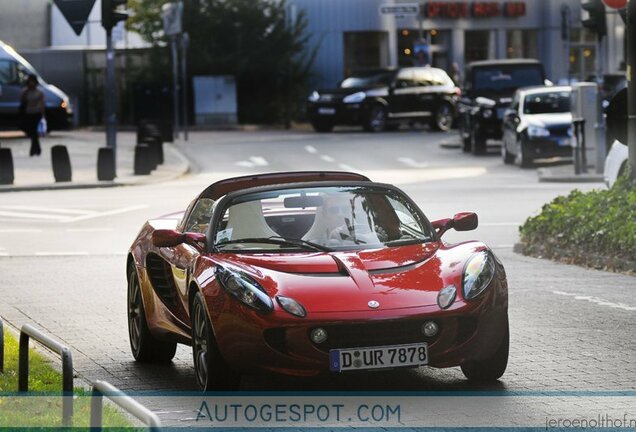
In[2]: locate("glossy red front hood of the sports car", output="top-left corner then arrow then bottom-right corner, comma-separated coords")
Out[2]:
215,242 -> 485,313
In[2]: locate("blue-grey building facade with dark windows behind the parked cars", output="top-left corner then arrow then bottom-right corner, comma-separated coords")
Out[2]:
290,0 -> 625,87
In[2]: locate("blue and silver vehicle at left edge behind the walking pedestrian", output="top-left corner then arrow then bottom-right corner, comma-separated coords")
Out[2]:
0,41 -> 73,130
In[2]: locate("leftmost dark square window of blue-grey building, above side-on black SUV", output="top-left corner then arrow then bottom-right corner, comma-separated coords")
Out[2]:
344,32 -> 389,76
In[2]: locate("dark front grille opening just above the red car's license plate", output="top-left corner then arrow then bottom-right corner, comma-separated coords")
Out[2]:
308,320 -> 441,351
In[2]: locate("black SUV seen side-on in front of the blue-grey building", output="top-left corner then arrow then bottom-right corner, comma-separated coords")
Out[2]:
307,67 -> 459,132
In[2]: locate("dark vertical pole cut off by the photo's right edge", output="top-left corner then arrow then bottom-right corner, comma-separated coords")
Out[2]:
627,0 -> 636,179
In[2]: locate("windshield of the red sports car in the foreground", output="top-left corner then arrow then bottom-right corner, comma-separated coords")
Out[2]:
214,186 -> 433,253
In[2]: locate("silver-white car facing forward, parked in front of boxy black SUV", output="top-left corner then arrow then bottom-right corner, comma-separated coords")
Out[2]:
501,86 -> 572,168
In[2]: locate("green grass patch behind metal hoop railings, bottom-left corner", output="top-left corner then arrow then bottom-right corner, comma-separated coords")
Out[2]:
0,331 -> 144,431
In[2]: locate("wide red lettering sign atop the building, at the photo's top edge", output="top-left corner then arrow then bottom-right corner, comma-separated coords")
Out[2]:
424,0 -> 528,19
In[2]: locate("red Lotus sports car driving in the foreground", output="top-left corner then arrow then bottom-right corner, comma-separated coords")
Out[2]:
127,172 -> 509,390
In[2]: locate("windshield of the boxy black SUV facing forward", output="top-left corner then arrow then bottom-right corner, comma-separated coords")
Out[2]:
473,66 -> 543,93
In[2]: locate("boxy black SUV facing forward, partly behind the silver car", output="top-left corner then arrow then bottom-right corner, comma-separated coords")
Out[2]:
458,59 -> 546,154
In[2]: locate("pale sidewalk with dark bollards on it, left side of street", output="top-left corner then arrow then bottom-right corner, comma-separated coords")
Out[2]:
0,130 -> 190,192
